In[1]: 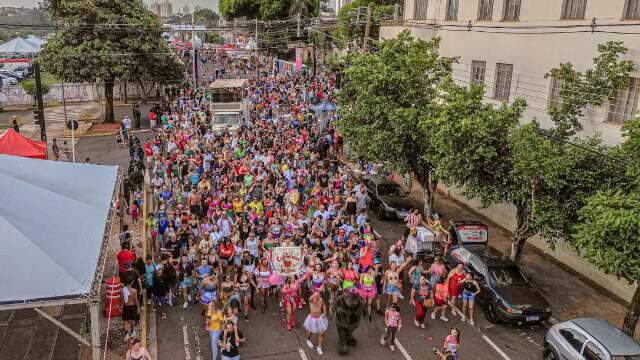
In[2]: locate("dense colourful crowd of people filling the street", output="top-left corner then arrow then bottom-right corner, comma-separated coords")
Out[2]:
118,51 -> 470,360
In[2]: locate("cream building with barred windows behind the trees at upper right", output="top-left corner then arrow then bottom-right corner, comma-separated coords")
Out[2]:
380,0 -> 640,143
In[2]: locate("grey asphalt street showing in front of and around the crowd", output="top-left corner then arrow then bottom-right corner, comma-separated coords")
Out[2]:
76,132 -> 545,360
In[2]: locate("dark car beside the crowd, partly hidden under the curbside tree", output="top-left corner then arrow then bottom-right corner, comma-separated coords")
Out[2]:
363,175 -> 415,220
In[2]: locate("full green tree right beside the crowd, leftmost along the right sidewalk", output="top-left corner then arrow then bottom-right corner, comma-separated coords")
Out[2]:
338,31 -> 453,215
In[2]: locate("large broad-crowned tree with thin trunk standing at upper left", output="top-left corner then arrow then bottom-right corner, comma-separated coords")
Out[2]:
40,0 -> 184,122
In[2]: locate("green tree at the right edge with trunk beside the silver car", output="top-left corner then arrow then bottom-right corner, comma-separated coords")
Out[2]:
572,119 -> 640,336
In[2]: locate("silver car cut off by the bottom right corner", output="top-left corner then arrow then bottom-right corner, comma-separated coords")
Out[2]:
543,318 -> 640,360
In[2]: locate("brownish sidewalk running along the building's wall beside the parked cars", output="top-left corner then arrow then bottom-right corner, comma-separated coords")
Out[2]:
402,176 -> 640,338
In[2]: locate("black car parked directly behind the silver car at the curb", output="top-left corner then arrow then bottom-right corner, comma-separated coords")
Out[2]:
446,237 -> 551,324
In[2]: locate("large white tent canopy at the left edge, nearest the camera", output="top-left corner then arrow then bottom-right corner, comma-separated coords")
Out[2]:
0,155 -> 118,306
